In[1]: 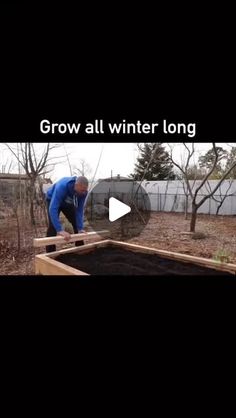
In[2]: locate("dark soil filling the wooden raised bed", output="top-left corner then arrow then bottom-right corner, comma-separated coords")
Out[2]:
56,247 -> 232,277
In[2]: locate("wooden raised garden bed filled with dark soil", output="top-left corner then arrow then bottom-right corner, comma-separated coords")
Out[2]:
35,235 -> 236,277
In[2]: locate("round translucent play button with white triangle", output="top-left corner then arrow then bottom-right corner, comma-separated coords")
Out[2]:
84,176 -> 151,241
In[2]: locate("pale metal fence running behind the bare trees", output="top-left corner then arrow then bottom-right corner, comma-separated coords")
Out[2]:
88,180 -> 236,215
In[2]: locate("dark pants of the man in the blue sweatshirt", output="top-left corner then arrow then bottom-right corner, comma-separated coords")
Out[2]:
46,200 -> 84,253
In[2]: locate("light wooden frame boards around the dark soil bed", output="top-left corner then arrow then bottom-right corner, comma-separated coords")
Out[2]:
35,239 -> 236,276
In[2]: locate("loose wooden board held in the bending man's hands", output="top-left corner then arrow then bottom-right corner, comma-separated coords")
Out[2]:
33,230 -> 109,247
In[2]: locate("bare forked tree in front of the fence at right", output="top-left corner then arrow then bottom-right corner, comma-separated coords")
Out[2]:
170,142 -> 236,232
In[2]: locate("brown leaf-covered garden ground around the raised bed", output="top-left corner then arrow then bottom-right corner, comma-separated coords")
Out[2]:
0,212 -> 236,275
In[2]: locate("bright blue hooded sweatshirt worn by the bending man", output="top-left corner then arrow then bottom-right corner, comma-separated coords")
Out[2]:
46,176 -> 87,232
